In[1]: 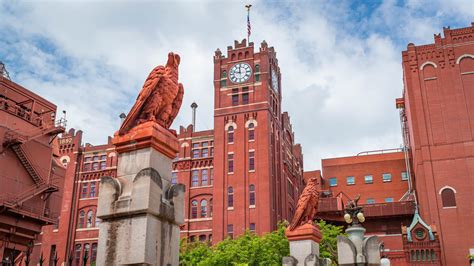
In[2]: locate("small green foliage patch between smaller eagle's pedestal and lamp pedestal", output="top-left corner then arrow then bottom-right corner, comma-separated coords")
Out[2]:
316,220 -> 345,264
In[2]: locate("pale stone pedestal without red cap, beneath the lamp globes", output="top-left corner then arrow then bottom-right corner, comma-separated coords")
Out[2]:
337,224 -> 381,266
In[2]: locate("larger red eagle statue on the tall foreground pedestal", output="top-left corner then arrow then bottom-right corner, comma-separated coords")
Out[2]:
119,53 -> 184,135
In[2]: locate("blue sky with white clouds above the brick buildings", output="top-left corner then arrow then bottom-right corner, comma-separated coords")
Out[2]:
0,0 -> 474,170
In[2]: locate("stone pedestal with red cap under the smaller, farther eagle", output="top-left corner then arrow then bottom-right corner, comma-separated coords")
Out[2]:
282,223 -> 327,266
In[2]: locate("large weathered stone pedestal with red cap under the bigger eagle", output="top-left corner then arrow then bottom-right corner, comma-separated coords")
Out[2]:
97,122 -> 184,265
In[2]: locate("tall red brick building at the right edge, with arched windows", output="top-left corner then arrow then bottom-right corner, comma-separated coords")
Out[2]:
397,23 -> 474,265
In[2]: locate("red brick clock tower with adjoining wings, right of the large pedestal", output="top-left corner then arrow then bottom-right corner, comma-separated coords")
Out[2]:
174,40 -> 303,242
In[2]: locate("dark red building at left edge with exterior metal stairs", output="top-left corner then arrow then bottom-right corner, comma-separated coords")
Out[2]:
0,76 -> 66,265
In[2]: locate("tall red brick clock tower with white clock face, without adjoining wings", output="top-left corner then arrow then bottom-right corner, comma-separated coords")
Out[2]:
213,39 -> 290,243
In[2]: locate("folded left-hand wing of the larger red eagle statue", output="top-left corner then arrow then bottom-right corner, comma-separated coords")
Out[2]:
119,66 -> 165,135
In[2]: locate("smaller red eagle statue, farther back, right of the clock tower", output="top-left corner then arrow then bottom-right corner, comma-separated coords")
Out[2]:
288,177 -> 319,231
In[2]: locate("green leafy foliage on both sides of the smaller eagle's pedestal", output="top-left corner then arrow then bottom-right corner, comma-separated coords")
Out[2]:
179,221 -> 343,266
